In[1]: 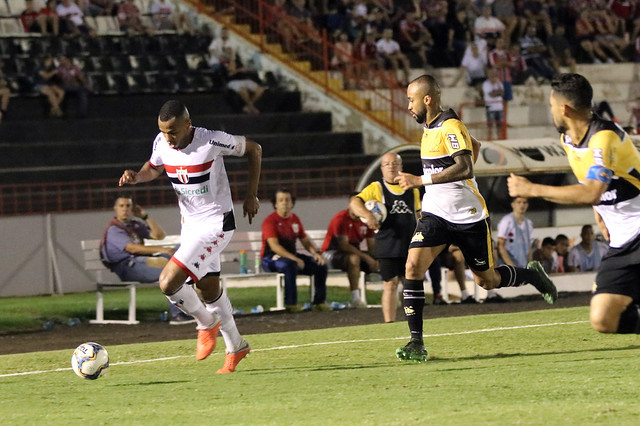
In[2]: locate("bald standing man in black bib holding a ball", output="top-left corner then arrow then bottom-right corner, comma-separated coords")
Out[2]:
349,152 -> 420,322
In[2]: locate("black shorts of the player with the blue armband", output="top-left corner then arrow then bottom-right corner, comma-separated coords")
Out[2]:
593,231 -> 640,303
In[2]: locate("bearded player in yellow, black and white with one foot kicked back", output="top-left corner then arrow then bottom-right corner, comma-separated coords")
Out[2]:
396,75 -> 558,361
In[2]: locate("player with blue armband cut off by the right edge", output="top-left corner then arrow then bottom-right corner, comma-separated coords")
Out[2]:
508,74 -> 640,334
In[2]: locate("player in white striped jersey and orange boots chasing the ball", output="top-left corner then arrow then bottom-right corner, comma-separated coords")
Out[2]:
119,100 -> 262,373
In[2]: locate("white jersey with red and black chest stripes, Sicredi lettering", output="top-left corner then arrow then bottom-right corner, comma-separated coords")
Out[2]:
149,127 -> 246,222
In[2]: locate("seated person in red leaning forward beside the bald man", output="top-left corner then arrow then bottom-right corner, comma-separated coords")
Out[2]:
321,202 -> 379,308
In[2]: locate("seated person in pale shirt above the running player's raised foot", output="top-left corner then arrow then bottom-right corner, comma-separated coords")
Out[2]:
485,197 -> 534,303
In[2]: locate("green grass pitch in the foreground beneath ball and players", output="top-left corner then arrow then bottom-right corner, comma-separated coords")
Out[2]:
0,308 -> 640,425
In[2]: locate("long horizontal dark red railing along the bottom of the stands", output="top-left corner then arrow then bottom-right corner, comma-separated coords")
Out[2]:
0,166 -> 366,216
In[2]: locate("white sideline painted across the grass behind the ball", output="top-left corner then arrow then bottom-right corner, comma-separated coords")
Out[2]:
0,321 -> 588,378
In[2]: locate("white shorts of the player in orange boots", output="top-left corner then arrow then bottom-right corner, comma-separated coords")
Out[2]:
171,215 -> 233,283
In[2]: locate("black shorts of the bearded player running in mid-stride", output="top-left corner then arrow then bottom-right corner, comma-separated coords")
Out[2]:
409,212 -> 494,272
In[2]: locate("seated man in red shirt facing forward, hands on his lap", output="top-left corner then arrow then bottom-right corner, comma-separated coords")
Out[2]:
261,188 -> 330,312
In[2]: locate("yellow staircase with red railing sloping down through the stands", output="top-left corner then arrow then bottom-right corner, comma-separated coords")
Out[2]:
186,0 -> 421,143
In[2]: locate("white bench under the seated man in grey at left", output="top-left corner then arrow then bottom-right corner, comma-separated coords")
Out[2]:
80,240 -> 157,324
